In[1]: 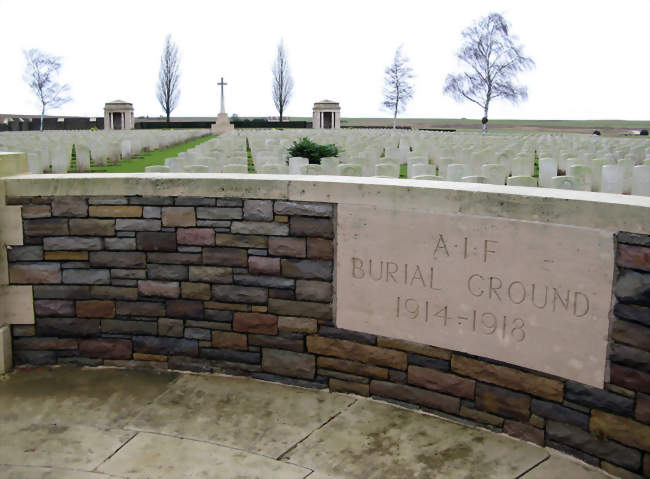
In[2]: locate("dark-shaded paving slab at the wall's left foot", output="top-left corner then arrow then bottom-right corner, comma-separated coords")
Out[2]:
0,366 -> 177,428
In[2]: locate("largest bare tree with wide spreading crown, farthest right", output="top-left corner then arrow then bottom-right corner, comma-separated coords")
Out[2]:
443,13 -> 535,134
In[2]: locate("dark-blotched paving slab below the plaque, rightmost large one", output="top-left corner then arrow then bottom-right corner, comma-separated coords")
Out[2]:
284,401 -> 548,479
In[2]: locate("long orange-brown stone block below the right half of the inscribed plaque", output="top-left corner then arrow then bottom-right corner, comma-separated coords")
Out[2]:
451,354 -> 564,402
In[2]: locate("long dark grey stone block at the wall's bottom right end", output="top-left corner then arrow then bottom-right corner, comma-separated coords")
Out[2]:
546,421 -> 641,469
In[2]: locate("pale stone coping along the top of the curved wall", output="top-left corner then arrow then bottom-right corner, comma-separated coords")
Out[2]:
0,173 -> 650,234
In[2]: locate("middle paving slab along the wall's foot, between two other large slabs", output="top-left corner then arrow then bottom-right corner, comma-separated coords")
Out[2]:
126,375 -> 355,458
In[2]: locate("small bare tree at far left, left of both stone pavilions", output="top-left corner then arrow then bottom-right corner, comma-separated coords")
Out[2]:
23,48 -> 72,131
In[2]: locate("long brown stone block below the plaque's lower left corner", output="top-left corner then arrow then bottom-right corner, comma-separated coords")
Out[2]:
307,336 -> 407,371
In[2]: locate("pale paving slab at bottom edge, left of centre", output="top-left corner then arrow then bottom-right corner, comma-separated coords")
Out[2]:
98,433 -> 311,479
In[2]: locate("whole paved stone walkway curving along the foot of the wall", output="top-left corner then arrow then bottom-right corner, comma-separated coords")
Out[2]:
0,367 -> 610,479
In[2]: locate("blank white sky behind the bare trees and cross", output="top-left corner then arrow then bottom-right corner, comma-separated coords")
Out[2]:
0,0 -> 650,121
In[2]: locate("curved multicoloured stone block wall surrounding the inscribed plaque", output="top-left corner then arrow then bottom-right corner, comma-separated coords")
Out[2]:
8,196 -> 650,477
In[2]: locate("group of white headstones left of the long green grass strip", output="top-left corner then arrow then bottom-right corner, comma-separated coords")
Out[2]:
0,129 -> 207,173
